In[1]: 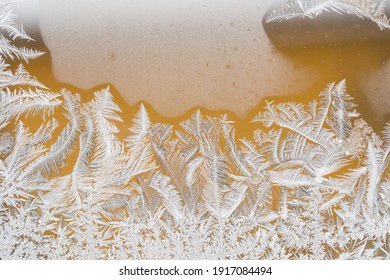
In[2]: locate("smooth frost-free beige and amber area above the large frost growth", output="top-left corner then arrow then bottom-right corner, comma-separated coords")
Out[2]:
13,0 -> 390,132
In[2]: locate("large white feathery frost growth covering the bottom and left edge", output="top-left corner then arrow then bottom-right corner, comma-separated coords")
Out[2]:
0,1 -> 390,259
